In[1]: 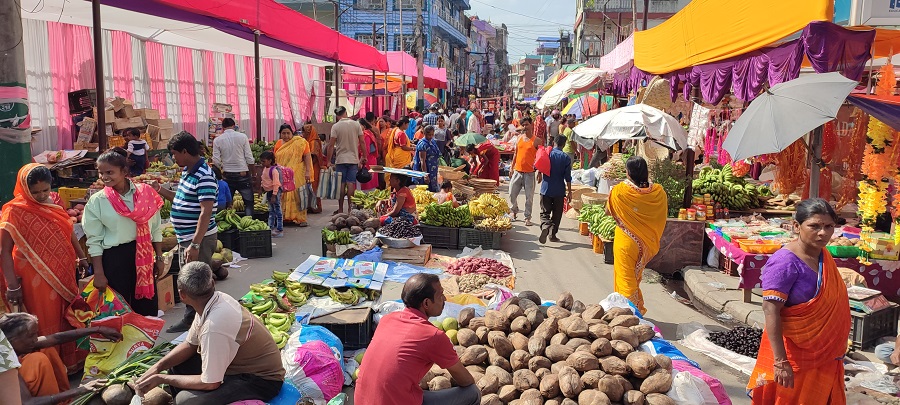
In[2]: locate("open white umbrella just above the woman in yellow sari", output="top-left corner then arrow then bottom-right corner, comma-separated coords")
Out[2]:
573,104 -> 687,150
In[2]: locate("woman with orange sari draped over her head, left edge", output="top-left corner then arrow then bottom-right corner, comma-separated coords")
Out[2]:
0,163 -> 88,369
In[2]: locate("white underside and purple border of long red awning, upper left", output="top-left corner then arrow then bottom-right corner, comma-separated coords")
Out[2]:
21,0 -> 386,66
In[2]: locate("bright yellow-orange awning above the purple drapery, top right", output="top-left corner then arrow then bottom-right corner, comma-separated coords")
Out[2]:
634,0 -> 834,74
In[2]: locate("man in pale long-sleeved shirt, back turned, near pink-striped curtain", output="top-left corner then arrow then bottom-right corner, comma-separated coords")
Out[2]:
212,118 -> 255,216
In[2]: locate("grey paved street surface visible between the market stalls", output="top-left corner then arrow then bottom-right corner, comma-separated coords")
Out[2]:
161,186 -> 750,405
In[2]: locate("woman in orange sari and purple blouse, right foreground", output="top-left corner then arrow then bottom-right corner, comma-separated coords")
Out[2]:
747,198 -> 850,405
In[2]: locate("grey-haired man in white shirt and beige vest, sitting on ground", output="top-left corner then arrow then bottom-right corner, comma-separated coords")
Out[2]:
134,262 -> 284,405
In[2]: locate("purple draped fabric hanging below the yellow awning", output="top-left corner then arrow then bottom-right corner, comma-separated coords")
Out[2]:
612,21 -> 875,104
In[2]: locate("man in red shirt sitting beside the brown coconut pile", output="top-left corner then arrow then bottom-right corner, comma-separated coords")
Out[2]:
354,272 -> 481,405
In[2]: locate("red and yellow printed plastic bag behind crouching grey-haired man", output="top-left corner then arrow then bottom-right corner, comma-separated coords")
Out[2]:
84,312 -> 166,379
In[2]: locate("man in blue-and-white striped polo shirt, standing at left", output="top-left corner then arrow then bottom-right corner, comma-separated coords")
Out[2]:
154,131 -> 219,333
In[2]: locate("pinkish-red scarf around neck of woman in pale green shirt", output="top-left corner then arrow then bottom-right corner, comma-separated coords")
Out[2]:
103,183 -> 163,299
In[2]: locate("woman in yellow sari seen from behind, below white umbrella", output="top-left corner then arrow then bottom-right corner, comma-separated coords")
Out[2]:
606,156 -> 668,314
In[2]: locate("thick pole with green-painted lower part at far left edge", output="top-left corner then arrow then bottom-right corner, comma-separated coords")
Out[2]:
0,1 -> 31,202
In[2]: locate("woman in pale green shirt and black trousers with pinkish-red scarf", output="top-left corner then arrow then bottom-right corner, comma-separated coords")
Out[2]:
82,150 -> 164,316
